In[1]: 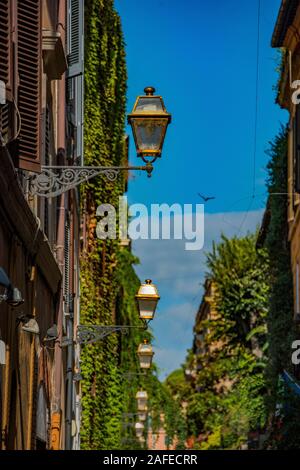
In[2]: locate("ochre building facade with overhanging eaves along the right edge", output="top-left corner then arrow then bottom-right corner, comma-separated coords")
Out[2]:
272,0 -> 300,318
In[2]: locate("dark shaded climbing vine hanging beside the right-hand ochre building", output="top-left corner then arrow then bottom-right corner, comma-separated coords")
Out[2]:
265,127 -> 300,449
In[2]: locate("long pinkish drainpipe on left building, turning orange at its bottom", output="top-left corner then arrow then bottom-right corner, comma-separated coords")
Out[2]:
51,0 -> 66,450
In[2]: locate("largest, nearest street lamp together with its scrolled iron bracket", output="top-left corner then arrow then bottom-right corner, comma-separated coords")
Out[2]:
26,87 -> 171,198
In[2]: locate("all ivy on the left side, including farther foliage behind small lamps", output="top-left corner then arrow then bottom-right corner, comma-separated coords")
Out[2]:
81,0 -> 184,450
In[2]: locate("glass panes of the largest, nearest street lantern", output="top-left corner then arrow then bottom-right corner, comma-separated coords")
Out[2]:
133,118 -> 168,153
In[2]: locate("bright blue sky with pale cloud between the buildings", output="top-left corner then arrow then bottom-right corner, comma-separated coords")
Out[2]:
115,0 -> 286,377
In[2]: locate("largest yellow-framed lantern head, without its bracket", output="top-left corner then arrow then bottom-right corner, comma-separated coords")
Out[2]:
128,87 -> 171,163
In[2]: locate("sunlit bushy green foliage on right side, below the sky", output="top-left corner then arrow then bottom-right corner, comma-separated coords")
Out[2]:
183,234 -> 269,450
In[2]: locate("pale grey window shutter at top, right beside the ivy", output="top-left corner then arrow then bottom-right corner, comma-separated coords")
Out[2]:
67,0 -> 84,78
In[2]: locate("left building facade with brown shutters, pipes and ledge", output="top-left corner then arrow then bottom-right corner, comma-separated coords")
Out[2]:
0,0 -> 83,450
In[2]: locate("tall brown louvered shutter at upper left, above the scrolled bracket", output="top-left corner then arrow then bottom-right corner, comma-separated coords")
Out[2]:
17,0 -> 42,172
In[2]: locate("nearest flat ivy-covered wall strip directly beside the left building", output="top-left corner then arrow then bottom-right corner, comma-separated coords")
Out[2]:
81,0 -> 132,449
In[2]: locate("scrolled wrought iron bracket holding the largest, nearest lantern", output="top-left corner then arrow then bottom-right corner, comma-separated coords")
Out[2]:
26,161 -> 153,198
